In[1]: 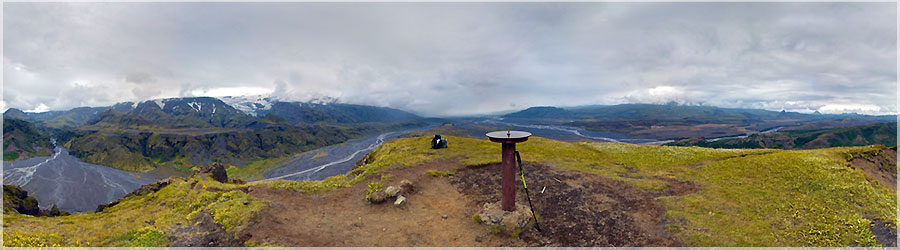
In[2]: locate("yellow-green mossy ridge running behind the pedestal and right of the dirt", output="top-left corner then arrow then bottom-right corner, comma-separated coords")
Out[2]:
253,136 -> 897,246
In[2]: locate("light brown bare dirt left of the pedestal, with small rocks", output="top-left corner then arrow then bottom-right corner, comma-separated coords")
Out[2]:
241,162 -> 525,247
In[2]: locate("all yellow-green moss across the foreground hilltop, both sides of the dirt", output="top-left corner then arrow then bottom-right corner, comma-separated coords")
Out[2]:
4,136 -> 897,246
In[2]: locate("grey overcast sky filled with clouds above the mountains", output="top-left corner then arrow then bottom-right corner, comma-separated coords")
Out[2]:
0,3 -> 897,116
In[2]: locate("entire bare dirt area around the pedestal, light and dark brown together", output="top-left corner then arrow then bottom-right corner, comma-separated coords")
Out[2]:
240,162 -> 696,246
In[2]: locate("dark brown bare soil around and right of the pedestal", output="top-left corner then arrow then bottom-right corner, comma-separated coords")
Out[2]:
451,163 -> 697,246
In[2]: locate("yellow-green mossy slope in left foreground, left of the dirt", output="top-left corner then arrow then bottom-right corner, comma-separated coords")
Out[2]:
3,178 -> 266,247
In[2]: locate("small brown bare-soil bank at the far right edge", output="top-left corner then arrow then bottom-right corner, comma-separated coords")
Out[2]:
850,147 -> 897,192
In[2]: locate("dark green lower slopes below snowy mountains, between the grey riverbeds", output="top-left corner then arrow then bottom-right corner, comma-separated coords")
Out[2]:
65,121 -> 425,173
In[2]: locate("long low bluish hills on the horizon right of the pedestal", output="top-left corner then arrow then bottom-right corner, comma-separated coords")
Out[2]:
503,104 -> 896,140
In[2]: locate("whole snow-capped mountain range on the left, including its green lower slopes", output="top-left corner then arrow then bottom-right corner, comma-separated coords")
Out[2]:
4,97 -> 427,174
